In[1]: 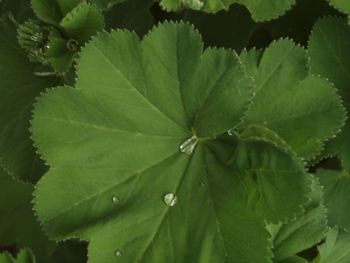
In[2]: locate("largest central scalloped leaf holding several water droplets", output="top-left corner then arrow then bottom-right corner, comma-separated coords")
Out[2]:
32,23 -> 309,263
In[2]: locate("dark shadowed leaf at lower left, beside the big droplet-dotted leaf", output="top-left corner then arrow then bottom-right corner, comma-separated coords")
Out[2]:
0,170 -> 53,258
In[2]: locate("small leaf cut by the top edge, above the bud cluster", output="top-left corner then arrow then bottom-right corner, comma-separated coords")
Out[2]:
31,0 -> 84,25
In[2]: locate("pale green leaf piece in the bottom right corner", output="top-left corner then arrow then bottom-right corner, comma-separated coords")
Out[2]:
315,228 -> 350,263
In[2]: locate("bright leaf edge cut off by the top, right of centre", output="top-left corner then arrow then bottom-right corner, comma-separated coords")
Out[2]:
160,0 -> 295,21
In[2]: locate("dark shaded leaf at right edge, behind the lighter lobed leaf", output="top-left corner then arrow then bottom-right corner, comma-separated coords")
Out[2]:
308,17 -> 350,170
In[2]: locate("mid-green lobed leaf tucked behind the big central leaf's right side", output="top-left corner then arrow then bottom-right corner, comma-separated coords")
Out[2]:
241,40 -> 345,159
